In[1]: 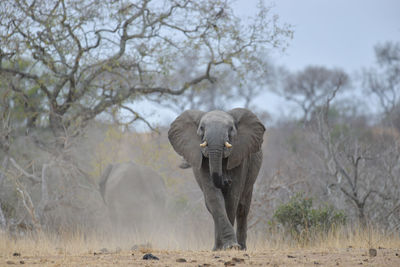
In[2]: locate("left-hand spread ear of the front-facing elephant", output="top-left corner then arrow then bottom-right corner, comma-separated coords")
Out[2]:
168,110 -> 205,169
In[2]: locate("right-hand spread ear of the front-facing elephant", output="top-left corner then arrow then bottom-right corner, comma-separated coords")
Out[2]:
227,108 -> 265,170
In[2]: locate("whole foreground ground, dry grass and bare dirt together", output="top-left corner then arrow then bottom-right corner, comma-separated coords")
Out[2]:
0,228 -> 400,266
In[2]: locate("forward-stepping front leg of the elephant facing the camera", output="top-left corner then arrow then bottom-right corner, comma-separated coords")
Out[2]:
204,184 -> 239,249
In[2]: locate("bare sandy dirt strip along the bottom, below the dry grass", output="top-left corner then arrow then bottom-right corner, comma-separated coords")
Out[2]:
0,247 -> 400,267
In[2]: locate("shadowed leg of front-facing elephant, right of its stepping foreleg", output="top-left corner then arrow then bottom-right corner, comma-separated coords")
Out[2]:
236,190 -> 253,250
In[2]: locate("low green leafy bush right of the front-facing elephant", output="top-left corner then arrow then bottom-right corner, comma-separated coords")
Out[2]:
274,193 -> 346,240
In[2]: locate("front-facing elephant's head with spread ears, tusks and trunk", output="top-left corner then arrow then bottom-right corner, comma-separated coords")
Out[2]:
168,108 -> 265,188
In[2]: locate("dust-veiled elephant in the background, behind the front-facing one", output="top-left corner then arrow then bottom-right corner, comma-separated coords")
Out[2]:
99,162 -> 167,232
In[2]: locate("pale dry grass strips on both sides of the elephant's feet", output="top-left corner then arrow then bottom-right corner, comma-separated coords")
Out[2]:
0,228 -> 400,255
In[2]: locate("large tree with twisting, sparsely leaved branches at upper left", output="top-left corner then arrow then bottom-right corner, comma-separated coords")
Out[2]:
0,0 -> 291,144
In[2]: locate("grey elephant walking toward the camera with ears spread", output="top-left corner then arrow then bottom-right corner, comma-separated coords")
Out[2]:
168,108 -> 265,250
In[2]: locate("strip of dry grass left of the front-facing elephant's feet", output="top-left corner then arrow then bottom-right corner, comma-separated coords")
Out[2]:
0,227 -> 213,255
